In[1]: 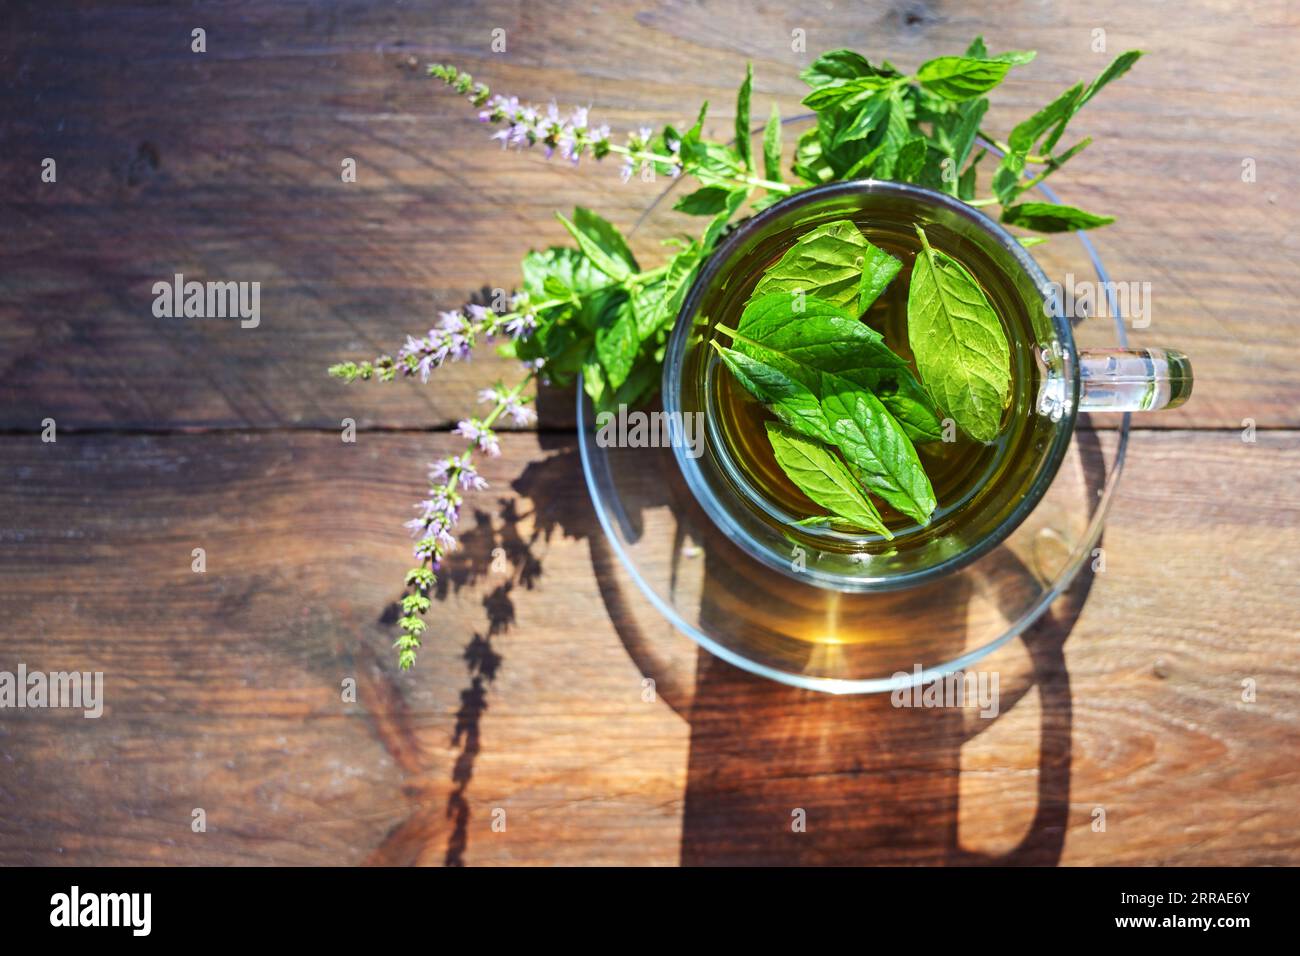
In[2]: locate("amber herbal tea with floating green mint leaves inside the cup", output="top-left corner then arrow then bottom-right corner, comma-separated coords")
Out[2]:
706,216 -> 1039,546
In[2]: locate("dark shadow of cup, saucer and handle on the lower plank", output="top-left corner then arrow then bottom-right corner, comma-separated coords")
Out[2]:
590,424 -> 1113,865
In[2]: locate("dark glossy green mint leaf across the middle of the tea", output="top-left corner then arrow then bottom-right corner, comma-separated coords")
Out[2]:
719,293 -> 943,441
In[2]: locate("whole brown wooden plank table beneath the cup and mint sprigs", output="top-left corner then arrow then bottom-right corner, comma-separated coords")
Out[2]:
0,0 -> 1300,865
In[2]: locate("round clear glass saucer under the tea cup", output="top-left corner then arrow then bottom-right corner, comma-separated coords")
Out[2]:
577,127 -> 1128,693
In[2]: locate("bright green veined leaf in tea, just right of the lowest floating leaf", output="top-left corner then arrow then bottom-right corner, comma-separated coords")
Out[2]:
822,372 -> 936,524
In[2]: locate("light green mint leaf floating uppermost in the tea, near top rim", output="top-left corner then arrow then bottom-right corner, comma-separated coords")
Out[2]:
754,220 -> 902,315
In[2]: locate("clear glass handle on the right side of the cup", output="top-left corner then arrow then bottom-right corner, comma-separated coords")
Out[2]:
1079,349 -> 1192,411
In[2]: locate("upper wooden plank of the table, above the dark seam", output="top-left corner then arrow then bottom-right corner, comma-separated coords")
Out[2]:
0,0 -> 1300,429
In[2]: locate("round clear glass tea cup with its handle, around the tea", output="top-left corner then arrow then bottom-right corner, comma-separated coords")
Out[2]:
663,179 -> 1192,592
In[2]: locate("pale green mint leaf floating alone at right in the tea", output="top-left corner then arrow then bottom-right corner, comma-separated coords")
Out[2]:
907,226 -> 1011,442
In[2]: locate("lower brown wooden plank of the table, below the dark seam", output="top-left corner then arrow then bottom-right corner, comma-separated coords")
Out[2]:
0,432 -> 1300,865
